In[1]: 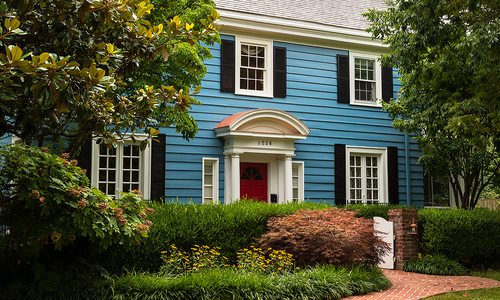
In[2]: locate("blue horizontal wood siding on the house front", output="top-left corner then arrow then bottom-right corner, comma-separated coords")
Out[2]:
162,36 -> 423,206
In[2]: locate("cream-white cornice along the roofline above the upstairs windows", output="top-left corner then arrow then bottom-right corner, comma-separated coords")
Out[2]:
218,9 -> 388,48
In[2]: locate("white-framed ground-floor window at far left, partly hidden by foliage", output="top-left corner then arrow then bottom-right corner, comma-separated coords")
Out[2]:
91,136 -> 151,199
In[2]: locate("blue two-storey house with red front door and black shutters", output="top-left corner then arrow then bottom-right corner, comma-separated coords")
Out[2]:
73,0 -> 424,206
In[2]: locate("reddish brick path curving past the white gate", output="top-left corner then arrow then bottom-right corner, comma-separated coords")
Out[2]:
344,270 -> 500,300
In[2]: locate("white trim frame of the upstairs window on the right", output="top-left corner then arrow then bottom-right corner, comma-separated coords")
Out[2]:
349,51 -> 382,107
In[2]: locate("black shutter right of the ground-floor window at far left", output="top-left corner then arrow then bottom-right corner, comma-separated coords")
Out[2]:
149,134 -> 166,200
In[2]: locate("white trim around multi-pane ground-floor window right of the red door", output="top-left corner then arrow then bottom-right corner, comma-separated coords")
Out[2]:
345,146 -> 389,203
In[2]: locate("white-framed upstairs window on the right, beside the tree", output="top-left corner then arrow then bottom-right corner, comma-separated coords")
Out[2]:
349,52 -> 382,106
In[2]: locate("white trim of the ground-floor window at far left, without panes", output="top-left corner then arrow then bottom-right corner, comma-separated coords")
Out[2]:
90,134 -> 151,199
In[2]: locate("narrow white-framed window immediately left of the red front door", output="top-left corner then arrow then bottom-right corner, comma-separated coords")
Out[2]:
201,157 -> 219,204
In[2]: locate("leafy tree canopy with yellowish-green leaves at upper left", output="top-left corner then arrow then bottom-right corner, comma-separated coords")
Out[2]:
0,0 -> 219,152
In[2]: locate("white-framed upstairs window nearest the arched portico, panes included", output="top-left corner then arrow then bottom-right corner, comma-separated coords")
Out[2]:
235,36 -> 273,97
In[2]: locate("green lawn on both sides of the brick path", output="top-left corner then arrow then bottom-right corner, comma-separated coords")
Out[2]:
426,269 -> 500,300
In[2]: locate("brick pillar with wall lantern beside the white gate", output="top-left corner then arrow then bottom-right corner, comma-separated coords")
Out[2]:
389,208 -> 418,270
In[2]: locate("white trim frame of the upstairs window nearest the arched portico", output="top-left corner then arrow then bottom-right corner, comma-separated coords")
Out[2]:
234,35 -> 273,98
